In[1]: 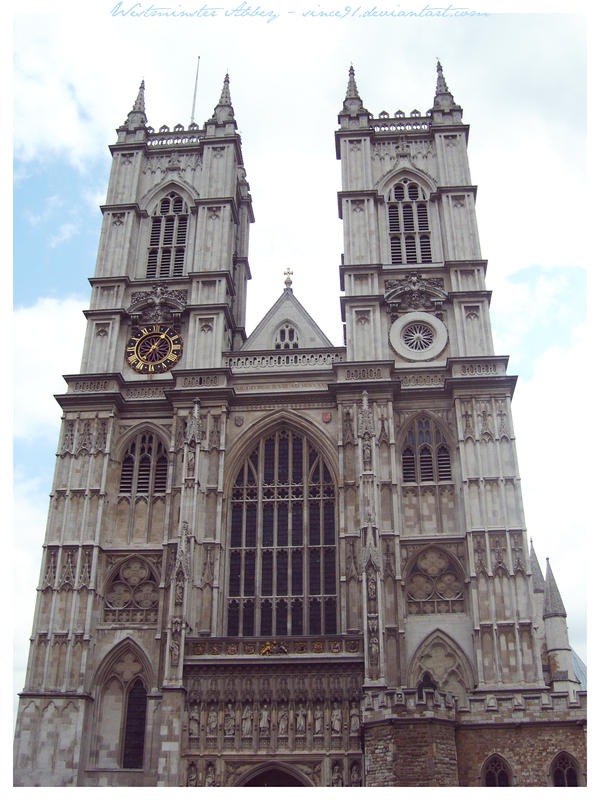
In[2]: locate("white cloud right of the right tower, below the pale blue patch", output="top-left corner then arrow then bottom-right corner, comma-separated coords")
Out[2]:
513,326 -> 596,660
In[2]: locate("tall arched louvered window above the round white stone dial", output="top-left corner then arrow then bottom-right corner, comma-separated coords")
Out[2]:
387,179 -> 431,264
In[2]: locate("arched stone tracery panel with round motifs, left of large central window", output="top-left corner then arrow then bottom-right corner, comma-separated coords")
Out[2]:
104,558 -> 158,624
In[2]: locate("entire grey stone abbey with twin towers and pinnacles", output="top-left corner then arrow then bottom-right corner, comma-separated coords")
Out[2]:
15,64 -> 586,787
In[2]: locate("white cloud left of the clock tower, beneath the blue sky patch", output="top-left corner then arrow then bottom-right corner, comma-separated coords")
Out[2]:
13,298 -> 87,446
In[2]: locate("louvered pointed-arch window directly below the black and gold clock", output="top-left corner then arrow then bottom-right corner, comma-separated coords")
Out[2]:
119,432 -> 169,497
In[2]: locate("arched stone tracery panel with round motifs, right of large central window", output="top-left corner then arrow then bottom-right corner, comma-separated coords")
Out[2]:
406,548 -> 464,614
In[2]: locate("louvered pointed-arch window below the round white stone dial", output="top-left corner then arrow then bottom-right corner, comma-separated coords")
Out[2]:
402,417 -> 452,483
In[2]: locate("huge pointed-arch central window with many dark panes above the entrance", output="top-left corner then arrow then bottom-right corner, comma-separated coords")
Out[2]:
226,429 -> 337,636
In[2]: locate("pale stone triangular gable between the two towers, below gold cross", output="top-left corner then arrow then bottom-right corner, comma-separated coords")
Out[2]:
241,289 -> 333,350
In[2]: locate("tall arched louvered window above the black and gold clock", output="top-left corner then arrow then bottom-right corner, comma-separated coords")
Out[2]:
146,192 -> 188,278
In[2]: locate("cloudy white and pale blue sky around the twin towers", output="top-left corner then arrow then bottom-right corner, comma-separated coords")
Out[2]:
12,0 -> 592,724
